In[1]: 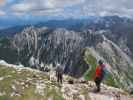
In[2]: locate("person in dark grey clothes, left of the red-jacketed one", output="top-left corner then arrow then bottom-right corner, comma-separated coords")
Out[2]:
56,64 -> 63,84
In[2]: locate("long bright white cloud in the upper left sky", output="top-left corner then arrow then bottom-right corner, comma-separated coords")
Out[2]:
11,0 -> 85,15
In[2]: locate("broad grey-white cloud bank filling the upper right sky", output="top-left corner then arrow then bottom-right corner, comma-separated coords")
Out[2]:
81,0 -> 133,17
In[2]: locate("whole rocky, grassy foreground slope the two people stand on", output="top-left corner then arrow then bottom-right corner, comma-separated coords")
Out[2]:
0,61 -> 133,100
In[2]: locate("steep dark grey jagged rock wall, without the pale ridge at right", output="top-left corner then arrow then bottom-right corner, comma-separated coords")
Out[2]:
12,27 -> 103,76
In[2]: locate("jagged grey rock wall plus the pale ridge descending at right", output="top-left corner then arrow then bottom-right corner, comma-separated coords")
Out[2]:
0,27 -> 133,89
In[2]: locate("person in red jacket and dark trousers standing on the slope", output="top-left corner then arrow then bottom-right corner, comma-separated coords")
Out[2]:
94,60 -> 105,92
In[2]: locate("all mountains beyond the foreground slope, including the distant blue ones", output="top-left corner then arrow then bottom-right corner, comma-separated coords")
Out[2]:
0,16 -> 133,90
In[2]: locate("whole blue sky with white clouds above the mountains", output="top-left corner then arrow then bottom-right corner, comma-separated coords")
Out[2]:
0,0 -> 133,18
